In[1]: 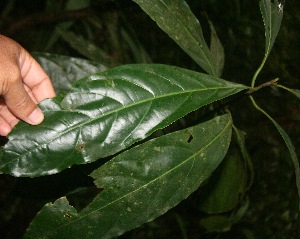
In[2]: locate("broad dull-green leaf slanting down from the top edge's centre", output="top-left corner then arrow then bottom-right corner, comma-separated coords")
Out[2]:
133,0 -> 218,76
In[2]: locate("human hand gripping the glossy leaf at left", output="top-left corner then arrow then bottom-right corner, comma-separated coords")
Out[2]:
0,35 -> 55,136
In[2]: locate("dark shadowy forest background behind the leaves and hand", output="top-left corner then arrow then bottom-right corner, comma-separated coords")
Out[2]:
0,0 -> 300,239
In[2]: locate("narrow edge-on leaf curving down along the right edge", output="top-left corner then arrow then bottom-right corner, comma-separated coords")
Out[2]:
250,96 -> 300,213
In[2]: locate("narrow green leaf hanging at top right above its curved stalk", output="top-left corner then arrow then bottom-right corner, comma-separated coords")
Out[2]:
259,0 -> 283,55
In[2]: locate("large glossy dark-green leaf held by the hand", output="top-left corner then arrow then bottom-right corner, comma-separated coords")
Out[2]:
0,65 -> 246,177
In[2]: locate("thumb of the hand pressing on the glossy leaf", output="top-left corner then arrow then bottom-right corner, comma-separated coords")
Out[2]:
3,77 -> 44,125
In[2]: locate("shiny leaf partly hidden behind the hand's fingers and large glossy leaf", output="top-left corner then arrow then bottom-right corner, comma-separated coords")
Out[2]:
33,53 -> 107,94
